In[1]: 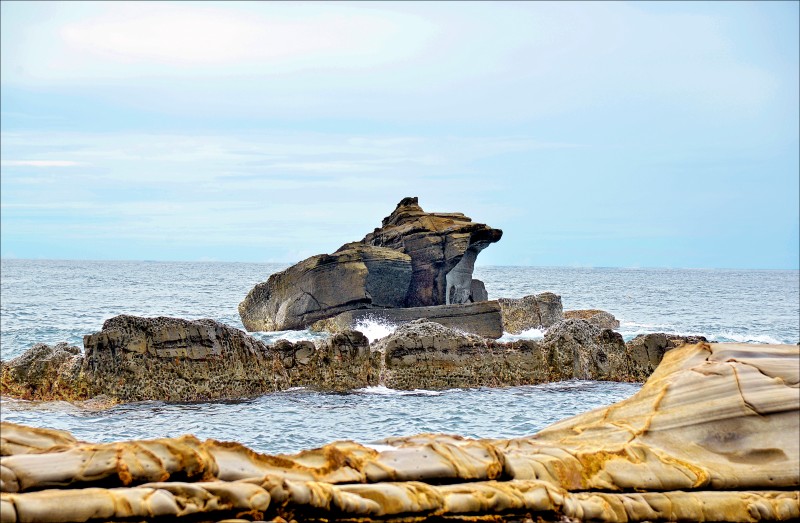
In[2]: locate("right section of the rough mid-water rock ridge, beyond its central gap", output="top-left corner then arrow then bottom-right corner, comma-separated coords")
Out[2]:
372,320 -> 651,390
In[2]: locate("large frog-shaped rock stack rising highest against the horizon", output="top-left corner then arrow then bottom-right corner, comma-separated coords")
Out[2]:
239,198 -> 503,331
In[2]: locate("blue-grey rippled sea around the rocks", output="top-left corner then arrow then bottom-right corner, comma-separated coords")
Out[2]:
0,259 -> 800,454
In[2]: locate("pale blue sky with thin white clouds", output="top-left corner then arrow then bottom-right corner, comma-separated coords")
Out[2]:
0,1 -> 800,269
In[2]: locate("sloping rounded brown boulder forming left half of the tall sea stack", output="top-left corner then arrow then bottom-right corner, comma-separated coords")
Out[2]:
239,243 -> 411,331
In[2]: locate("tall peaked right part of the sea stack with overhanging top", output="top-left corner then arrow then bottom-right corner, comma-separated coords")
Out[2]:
362,198 -> 503,307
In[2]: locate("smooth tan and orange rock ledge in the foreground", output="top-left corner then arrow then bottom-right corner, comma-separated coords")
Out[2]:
0,343 -> 800,523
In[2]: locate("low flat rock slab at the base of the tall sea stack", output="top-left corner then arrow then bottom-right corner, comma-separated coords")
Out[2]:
311,301 -> 503,339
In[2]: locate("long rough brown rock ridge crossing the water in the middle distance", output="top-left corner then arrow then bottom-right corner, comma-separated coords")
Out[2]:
0,316 -> 667,404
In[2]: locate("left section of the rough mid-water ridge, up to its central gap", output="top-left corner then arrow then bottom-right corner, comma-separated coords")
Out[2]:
0,316 -> 380,402
